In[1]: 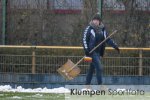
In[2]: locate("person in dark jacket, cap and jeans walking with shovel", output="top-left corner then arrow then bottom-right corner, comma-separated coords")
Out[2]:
82,14 -> 120,85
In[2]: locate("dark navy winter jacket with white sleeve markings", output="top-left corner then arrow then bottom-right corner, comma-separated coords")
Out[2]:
82,23 -> 118,56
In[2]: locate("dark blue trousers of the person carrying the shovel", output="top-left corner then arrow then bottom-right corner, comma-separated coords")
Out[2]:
86,52 -> 102,85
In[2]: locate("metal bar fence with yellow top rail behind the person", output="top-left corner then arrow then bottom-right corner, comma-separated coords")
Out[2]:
0,46 -> 150,76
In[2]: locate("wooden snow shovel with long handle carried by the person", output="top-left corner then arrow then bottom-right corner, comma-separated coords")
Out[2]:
57,30 -> 117,80
